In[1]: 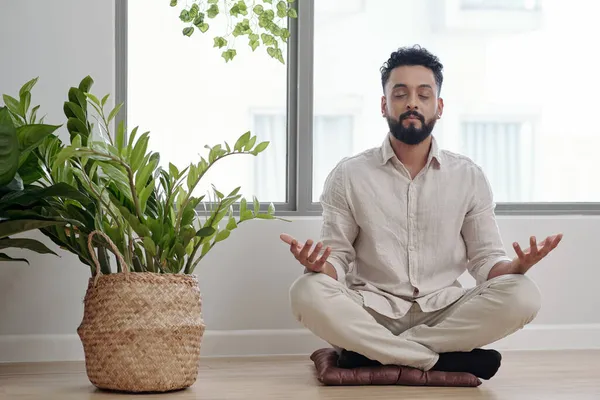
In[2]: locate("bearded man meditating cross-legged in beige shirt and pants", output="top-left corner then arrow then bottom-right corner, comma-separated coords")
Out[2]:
281,46 -> 562,379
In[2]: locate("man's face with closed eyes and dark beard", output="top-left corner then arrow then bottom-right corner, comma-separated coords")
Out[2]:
381,66 -> 444,145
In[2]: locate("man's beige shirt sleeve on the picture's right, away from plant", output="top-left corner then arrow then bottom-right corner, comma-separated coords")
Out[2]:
461,167 -> 512,285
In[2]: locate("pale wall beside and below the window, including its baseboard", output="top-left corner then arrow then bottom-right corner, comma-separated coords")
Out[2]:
0,0 -> 600,362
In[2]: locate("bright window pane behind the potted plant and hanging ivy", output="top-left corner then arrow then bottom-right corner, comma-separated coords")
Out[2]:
127,0 -> 287,202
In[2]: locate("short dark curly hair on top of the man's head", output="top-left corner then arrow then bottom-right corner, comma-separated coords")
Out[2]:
381,45 -> 444,95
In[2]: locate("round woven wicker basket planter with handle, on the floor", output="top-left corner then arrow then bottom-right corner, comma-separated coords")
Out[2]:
77,232 -> 205,392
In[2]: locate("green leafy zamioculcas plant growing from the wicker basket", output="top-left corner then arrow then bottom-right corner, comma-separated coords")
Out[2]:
42,77 -> 286,274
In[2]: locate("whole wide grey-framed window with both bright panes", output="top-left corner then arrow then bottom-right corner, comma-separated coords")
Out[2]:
117,0 -> 600,215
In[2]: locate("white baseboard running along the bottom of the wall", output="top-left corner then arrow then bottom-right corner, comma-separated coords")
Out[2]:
0,324 -> 600,363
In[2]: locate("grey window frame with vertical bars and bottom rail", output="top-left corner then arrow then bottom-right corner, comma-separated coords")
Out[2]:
115,0 -> 600,217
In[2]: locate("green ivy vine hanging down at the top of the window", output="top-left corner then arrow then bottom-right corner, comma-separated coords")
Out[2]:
169,0 -> 298,64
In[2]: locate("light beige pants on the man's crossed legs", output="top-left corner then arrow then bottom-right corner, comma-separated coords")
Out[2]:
290,273 -> 541,371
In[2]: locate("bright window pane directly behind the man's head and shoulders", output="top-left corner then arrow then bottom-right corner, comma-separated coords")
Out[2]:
313,0 -> 600,202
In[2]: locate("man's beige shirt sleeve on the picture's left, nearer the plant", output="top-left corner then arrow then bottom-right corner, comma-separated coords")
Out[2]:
320,161 -> 359,282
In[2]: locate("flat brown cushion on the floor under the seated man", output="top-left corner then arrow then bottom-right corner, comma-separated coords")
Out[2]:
310,348 -> 481,387
